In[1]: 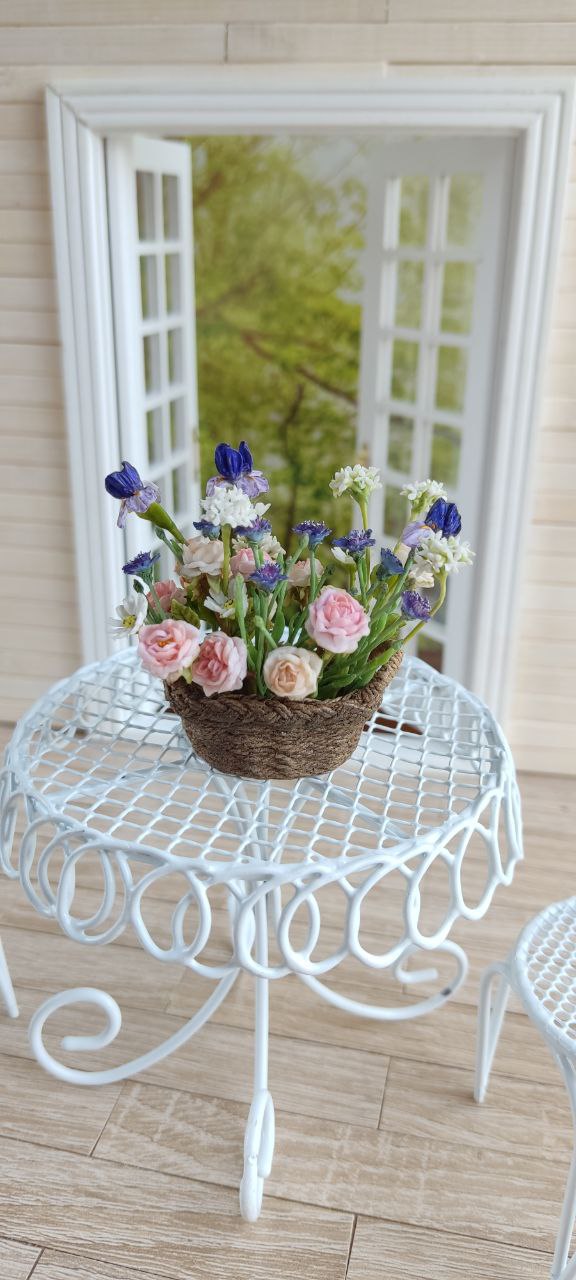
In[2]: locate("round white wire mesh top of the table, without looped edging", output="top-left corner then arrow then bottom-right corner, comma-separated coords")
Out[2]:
6,650 -> 509,861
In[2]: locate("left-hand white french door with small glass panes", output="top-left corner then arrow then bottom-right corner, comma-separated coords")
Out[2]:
106,136 -> 200,558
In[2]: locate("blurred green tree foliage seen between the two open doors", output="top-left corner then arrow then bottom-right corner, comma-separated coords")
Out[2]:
191,137 -> 366,545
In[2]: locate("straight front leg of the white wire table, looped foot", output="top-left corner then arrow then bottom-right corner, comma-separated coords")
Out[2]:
239,893 -> 274,1222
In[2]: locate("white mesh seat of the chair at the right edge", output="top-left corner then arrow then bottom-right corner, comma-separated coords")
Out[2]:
515,897 -> 576,1053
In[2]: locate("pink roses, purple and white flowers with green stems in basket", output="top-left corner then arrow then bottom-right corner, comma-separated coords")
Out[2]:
105,442 -> 472,778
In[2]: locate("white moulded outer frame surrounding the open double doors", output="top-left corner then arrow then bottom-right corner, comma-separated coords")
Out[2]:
46,65 -> 575,716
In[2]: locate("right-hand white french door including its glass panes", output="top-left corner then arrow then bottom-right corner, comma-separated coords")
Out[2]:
358,136 -> 513,681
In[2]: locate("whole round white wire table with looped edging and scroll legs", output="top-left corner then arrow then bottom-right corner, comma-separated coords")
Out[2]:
0,650 -> 522,1221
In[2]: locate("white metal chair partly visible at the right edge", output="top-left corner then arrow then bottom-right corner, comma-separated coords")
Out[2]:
474,897 -> 576,1280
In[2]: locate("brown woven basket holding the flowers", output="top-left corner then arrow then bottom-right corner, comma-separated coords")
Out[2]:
164,652 -> 402,778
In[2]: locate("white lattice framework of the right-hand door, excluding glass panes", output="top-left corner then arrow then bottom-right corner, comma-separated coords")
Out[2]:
358,133 -> 516,684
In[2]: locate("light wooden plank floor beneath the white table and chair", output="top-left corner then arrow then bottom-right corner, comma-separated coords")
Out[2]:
0,737 -> 576,1280
